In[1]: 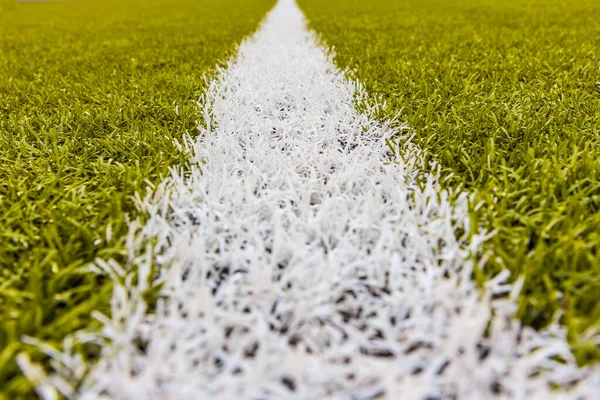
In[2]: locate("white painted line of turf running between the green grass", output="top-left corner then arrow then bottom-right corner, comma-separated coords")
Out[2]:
19,0 -> 600,399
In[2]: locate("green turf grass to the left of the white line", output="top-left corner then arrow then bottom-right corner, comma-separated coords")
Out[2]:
0,0 -> 274,399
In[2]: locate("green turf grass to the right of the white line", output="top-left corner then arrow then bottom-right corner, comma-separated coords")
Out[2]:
299,0 -> 600,362
